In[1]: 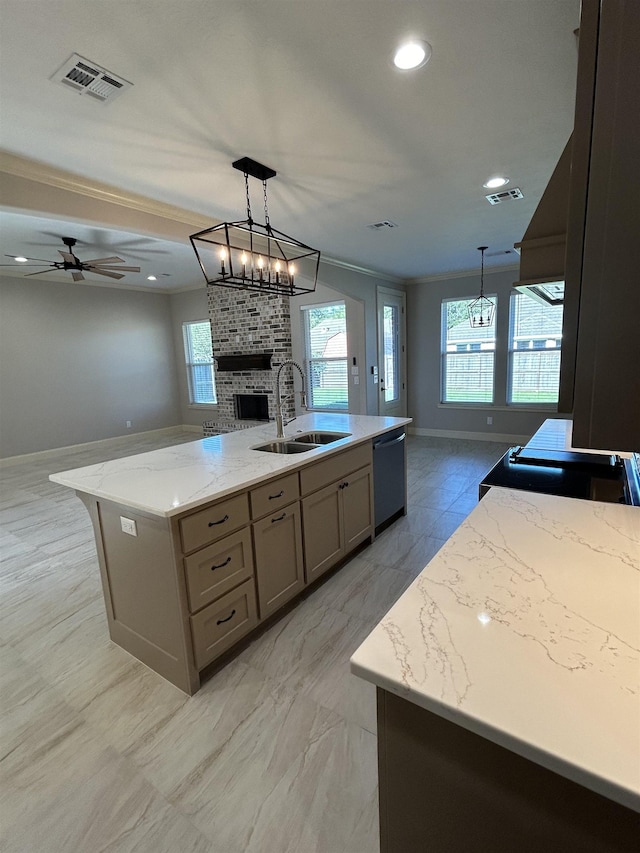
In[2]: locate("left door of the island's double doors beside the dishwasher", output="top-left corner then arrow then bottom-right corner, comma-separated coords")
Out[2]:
302,483 -> 344,583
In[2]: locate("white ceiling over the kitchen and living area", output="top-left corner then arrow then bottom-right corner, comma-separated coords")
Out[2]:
0,0 -> 579,290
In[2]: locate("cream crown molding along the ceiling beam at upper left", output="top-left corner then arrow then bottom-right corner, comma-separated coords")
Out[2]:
0,151 -> 215,229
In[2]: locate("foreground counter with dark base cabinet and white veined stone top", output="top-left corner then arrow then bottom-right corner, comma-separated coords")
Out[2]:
351,488 -> 640,853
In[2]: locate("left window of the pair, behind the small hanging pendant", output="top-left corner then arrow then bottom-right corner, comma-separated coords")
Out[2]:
441,296 -> 496,403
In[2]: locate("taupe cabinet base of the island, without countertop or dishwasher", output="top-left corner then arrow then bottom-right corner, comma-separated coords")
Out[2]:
82,442 -> 380,693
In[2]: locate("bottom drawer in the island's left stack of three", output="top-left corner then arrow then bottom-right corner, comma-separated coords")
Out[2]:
191,579 -> 258,669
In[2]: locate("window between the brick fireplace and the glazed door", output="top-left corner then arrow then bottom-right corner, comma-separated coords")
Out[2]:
300,302 -> 349,412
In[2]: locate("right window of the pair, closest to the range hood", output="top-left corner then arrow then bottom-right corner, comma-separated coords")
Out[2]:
507,293 -> 562,404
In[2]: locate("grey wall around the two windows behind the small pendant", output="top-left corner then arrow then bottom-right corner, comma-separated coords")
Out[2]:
407,270 -> 567,438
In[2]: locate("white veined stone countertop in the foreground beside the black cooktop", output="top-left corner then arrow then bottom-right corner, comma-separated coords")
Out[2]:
351,488 -> 640,811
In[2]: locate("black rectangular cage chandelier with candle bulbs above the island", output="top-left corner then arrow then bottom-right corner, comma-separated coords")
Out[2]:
189,157 -> 320,296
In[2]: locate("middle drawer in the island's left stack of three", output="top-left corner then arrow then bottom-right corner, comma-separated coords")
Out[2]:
184,527 -> 253,613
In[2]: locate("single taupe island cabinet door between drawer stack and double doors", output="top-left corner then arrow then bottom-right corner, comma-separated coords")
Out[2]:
253,503 -> 304,619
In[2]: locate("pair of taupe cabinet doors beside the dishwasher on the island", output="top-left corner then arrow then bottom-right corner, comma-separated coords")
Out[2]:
302,465 -> 373,583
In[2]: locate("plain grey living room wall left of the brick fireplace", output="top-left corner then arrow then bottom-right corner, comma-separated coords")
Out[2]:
0,276 -> 181,458
